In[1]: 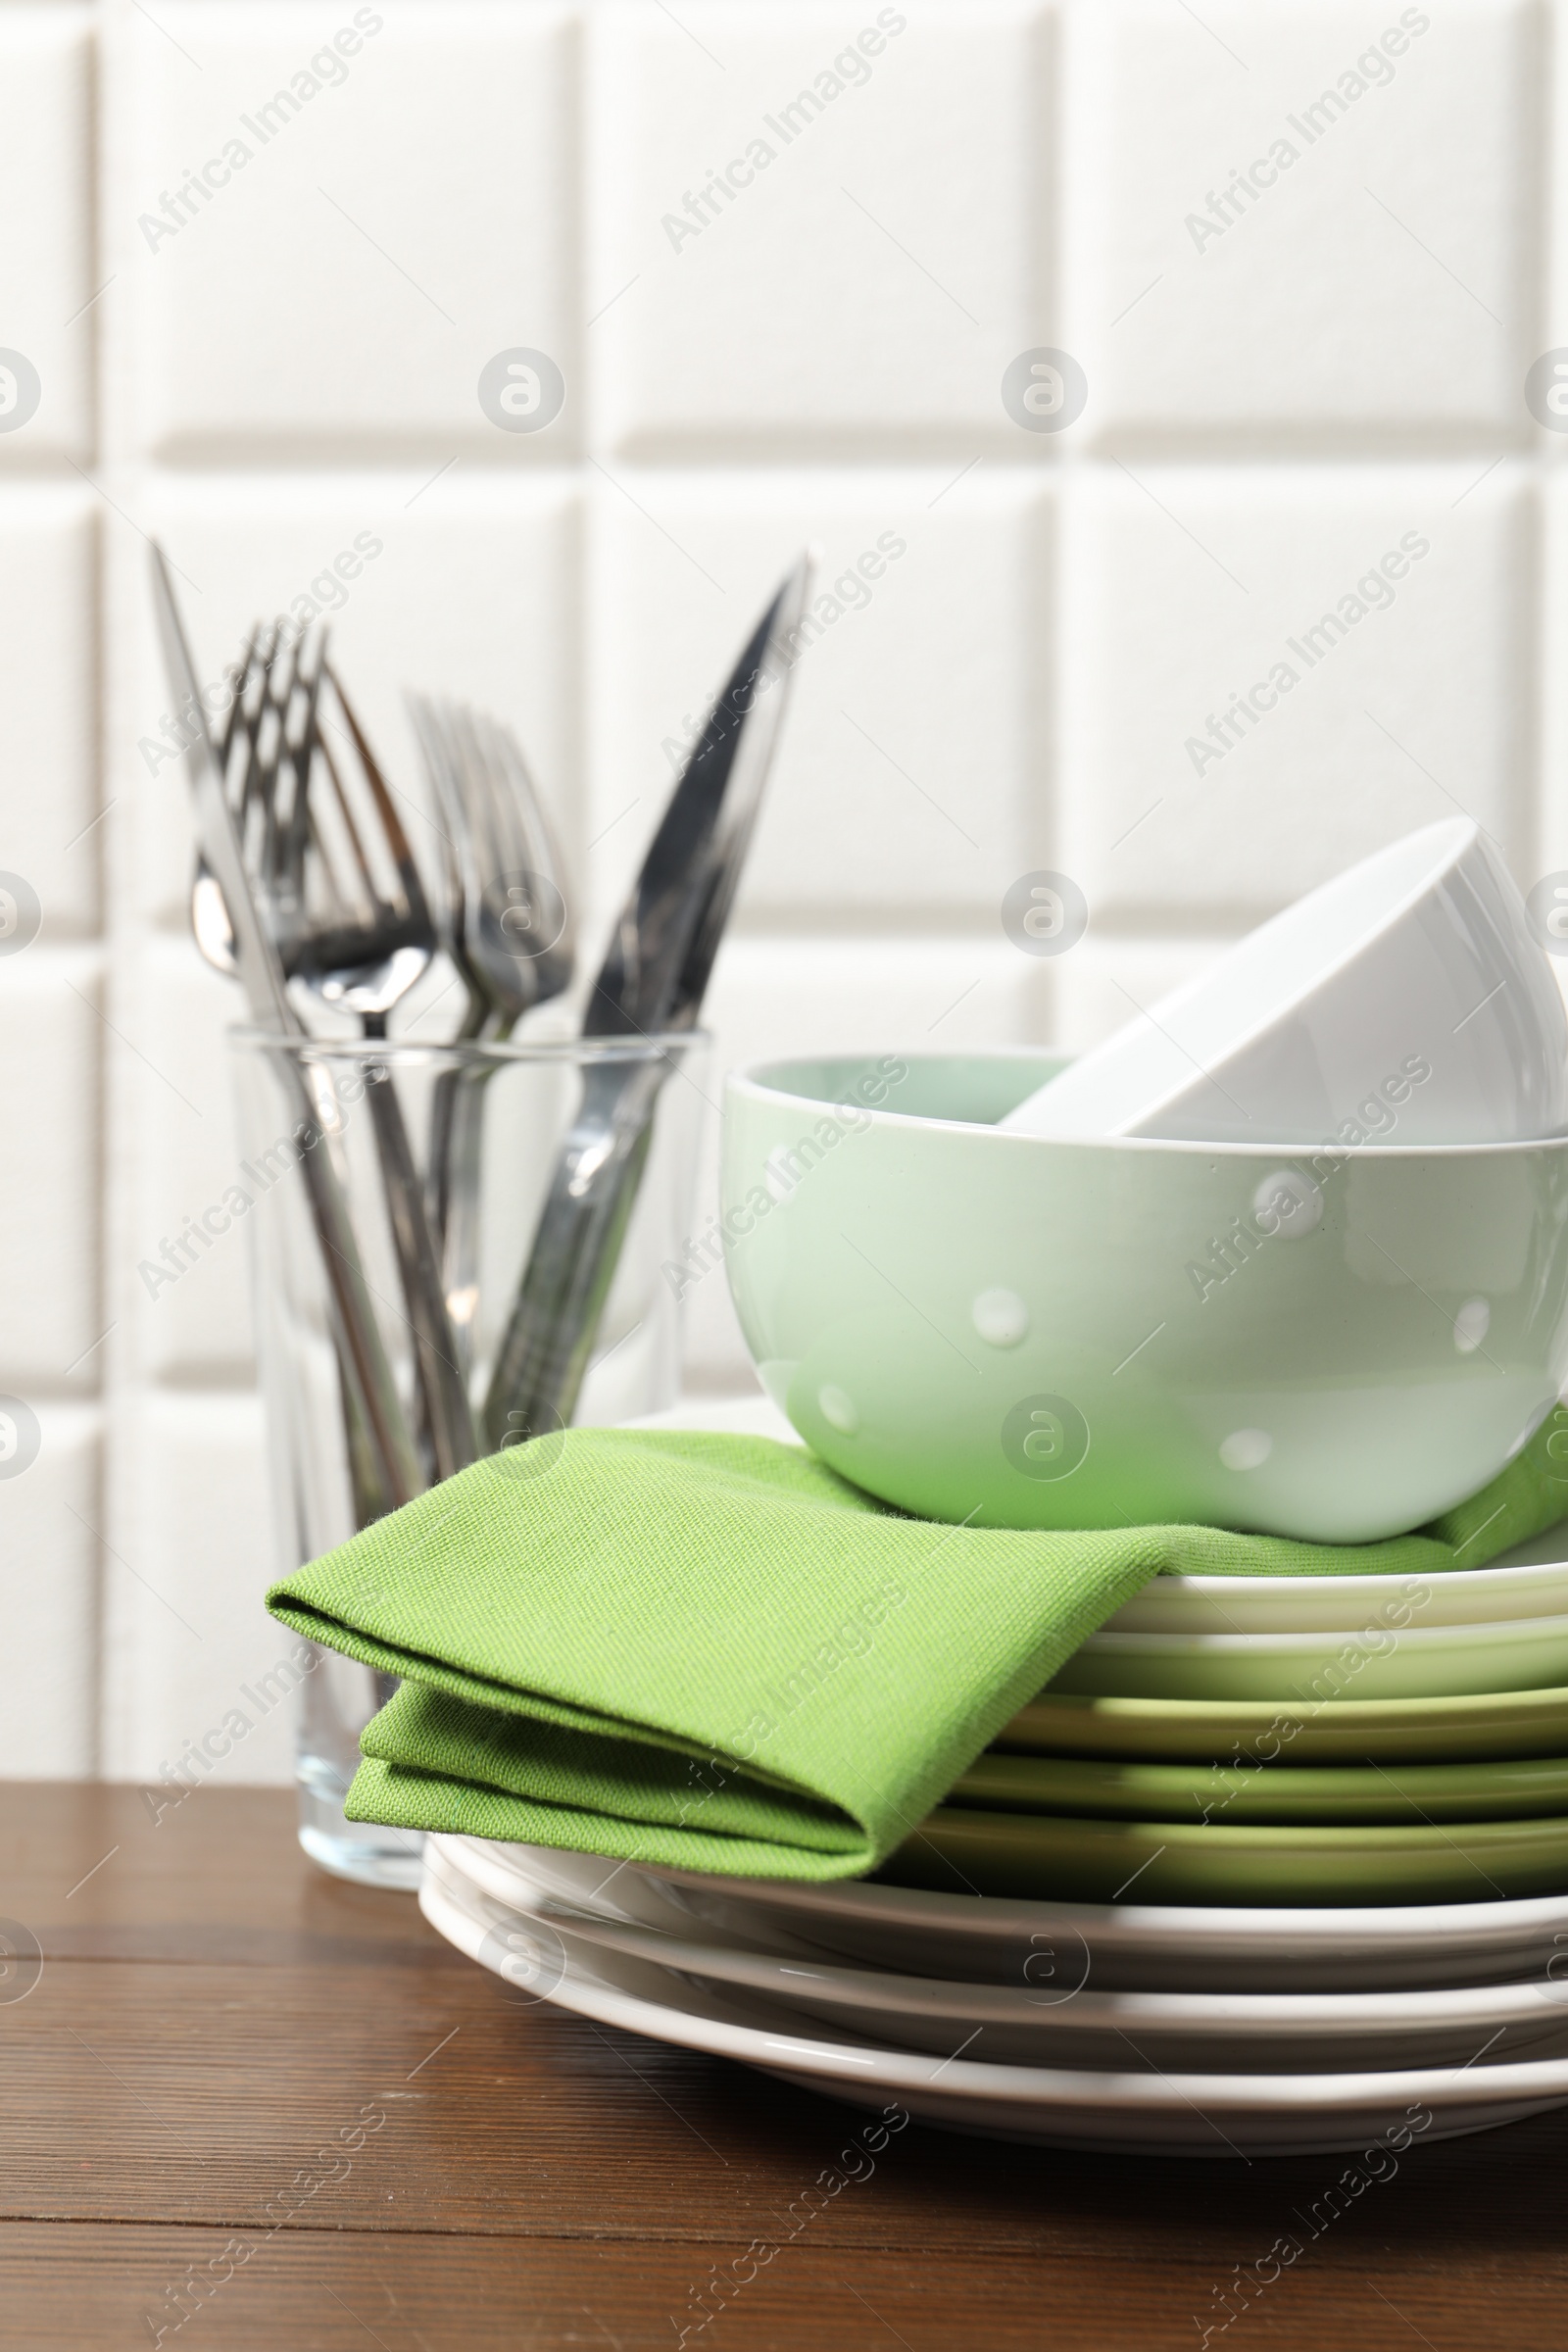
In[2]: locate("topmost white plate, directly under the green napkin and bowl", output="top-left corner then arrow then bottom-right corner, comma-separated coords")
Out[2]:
632,1397 -> 1568,1642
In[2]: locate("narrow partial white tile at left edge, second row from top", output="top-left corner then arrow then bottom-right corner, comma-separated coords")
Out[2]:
0,484 -> 101,941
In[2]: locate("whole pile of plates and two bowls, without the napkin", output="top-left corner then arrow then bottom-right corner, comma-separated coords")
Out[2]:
411,821 -> 1568,2154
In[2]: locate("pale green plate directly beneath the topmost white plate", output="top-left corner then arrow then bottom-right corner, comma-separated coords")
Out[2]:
1051,1616 -> 1568,1698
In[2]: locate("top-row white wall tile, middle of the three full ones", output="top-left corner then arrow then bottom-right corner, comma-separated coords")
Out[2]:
585,0 -> 1051,461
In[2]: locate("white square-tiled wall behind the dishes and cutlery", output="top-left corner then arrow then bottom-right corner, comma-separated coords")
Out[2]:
0,0 -> 1568,1778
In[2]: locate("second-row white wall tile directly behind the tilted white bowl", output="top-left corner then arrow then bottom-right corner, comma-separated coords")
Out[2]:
1060,464 -> 1533,931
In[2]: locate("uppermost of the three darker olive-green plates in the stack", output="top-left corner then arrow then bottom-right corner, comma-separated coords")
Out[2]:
995,1689 -> 1568,1764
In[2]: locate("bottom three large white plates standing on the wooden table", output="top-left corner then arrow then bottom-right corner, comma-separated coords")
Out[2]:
420,1837 -> 1568,2157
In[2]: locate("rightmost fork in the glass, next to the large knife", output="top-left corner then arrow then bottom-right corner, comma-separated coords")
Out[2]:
409,694 -> 576,1364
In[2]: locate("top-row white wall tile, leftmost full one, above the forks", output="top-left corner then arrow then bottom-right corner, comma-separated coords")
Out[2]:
113,0 -> 576,461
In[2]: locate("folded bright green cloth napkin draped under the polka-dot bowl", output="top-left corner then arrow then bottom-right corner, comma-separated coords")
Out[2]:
268,1406 -> 1568,1880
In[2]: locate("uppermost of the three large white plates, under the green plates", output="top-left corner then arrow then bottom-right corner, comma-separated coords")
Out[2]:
442,1837 -> 1568,1992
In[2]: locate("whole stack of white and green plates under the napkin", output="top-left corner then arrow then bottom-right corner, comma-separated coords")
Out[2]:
420,1531 -> 1568,2157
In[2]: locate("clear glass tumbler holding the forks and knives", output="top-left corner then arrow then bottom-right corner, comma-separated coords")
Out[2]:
225,1030 -> 708,1886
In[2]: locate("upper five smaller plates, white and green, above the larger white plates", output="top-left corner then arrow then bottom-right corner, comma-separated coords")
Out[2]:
889,1529 -> 1568,1909
